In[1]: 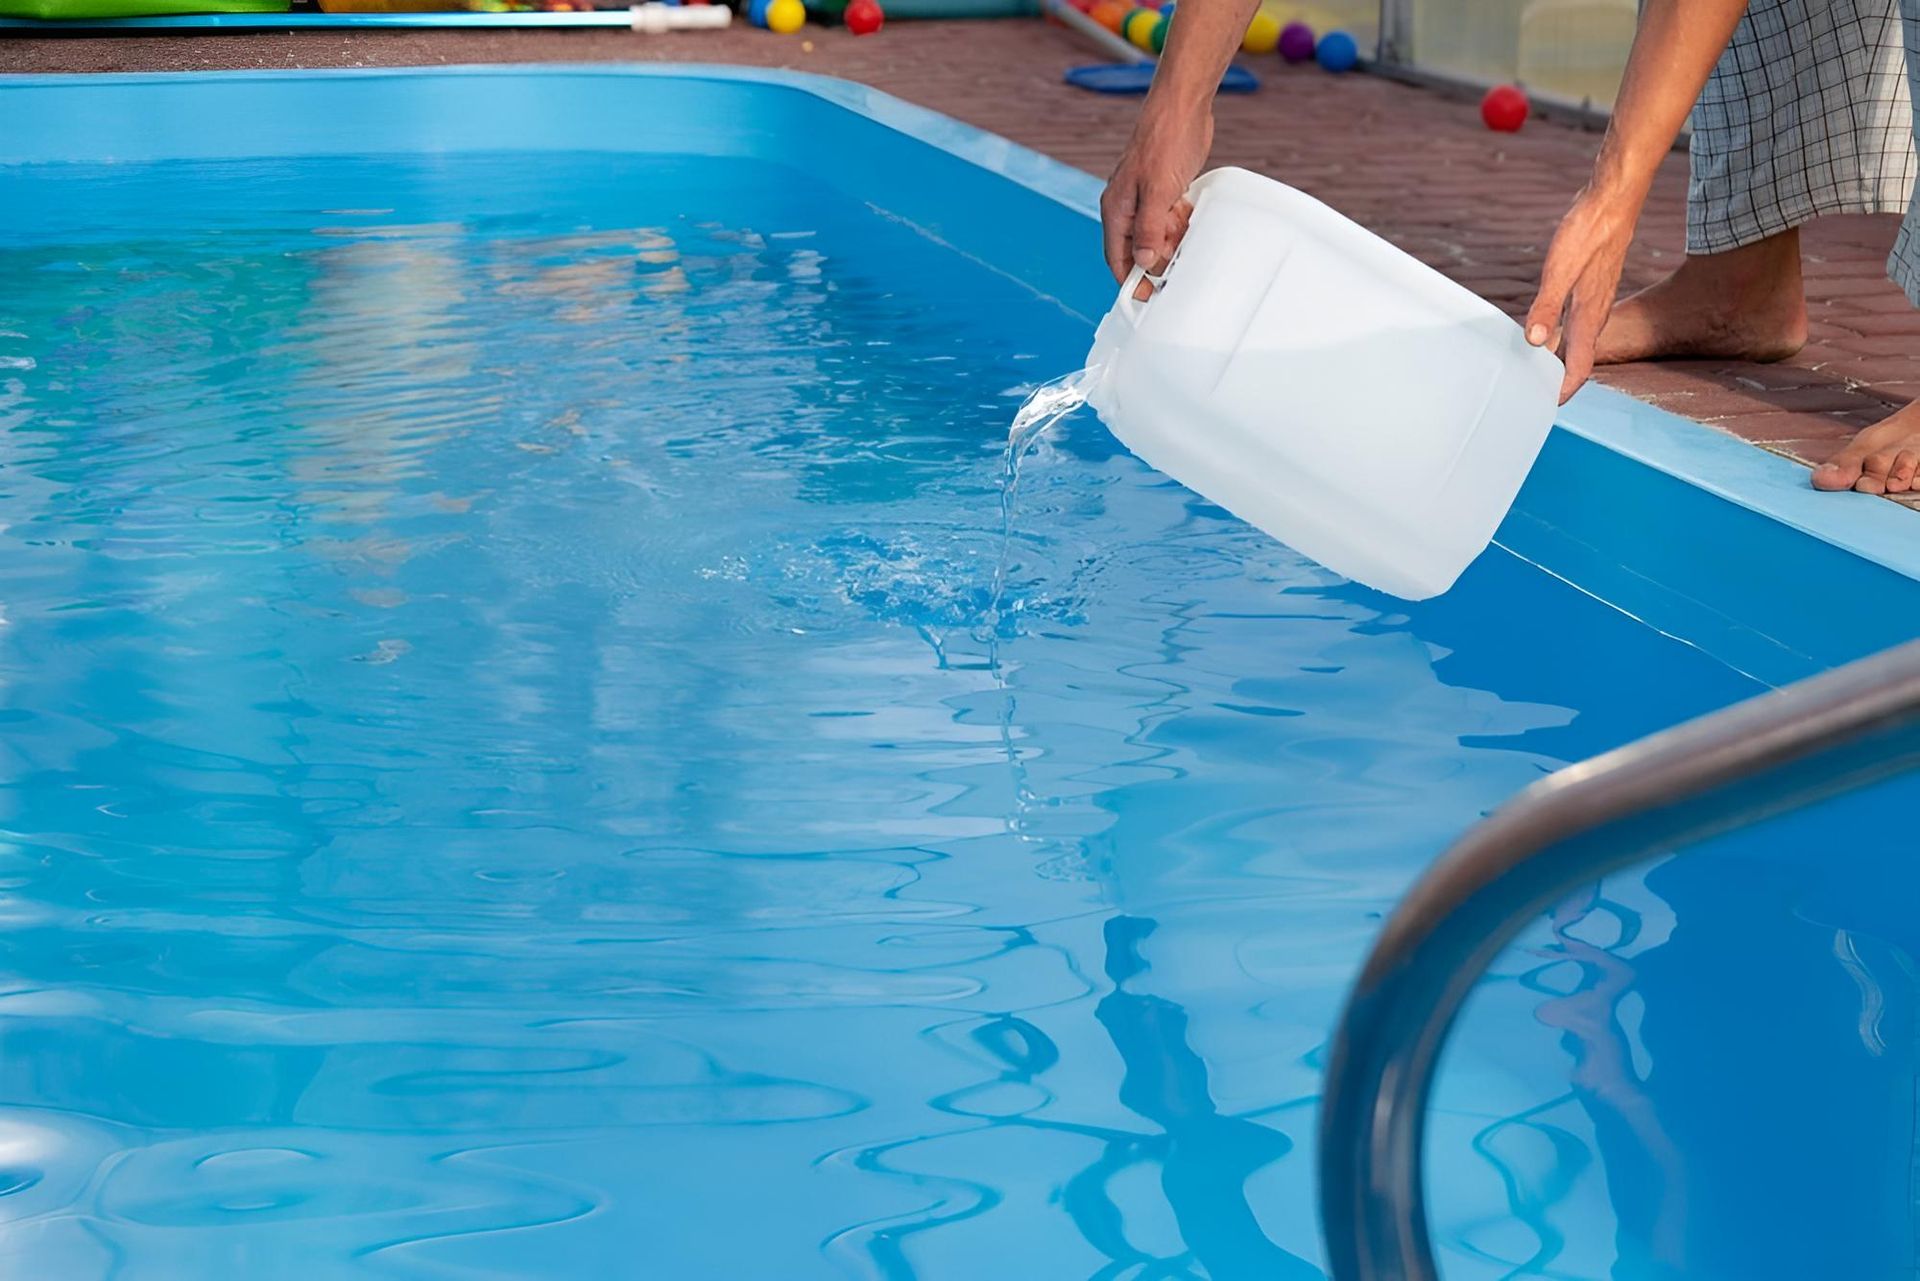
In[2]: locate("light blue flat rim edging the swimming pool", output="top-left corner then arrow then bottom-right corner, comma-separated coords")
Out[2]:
11,61 -> 1920,580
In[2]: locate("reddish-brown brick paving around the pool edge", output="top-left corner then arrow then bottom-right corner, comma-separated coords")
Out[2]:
11,19 -> 1920,507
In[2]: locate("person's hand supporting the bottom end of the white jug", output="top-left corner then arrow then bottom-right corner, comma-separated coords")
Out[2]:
1526,186 -> 1642,405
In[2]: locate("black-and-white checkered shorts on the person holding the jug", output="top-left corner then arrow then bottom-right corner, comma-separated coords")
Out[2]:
1686,0 -> 1920,300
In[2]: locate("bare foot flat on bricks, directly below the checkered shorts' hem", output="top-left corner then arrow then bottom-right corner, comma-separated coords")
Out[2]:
1594,229 -> 1807,365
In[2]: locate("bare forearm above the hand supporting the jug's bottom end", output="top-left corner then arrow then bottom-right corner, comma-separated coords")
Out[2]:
1594,0 -> 1747,207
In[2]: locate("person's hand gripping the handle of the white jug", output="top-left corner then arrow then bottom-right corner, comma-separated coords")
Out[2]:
1100,98 -> 1213,288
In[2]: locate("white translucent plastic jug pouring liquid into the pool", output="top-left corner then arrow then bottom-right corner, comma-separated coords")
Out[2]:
1087,169 -> 1561,599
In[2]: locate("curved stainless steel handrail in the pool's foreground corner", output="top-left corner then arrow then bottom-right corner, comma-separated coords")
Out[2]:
1319,641 -> 1920,1281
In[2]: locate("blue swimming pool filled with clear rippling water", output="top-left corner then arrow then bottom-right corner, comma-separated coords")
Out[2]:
0,69 -> 1920,1281
